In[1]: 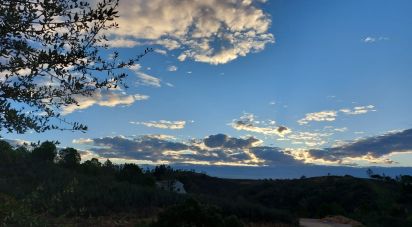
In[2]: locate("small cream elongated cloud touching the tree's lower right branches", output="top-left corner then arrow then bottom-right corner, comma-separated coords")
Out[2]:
62,90 -> 149,115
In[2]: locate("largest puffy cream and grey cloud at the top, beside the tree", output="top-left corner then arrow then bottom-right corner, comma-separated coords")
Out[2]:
109,0 -> 274,64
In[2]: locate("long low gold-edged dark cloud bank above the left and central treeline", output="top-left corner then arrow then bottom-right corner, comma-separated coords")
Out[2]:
76,134 -> 301,166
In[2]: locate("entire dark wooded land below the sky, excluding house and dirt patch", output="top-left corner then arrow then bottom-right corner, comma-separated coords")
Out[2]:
0,140 -> 412,227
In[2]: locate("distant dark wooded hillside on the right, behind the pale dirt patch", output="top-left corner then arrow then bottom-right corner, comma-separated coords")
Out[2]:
178,173 -> 412,226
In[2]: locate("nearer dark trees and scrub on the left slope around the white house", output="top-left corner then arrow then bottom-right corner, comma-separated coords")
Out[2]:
0,140 -> 251,227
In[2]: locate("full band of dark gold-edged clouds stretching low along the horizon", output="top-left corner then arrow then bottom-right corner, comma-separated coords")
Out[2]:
73,129 -> 412,166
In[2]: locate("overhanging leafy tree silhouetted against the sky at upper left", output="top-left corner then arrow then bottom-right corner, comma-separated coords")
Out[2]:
0,0 -> 150,133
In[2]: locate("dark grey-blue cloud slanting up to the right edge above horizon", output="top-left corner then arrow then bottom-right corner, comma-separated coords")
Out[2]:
309,129 -> 412,161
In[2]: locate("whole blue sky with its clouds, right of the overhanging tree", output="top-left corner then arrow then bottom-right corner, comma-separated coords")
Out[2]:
3,0 -> 412,177
